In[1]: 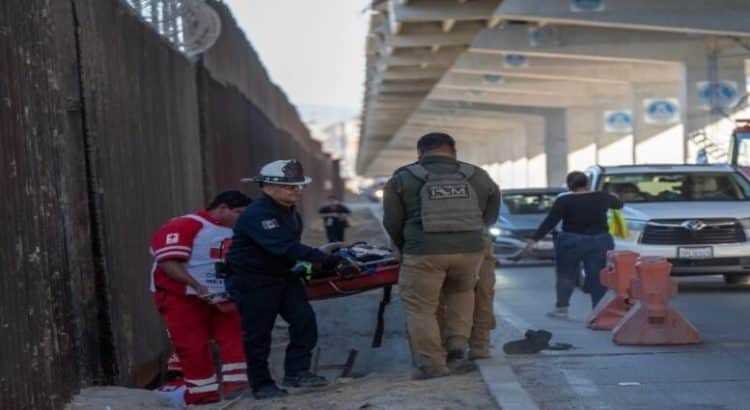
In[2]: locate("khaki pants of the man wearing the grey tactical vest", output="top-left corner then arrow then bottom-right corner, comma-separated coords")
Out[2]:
398,252 -> 483,371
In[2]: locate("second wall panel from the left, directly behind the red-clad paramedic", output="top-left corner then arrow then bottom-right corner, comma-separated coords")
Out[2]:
76,0 -> 203,384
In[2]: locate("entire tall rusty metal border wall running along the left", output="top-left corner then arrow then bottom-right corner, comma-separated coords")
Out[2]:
0,0 -> 341,410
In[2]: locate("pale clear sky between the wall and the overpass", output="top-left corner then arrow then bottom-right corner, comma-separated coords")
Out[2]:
224,0 -> 370,112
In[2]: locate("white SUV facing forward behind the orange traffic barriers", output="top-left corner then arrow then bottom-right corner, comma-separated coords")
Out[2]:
586,165 -> 750,283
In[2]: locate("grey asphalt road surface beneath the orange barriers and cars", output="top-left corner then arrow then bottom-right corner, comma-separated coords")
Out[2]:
490,266 -> 750,410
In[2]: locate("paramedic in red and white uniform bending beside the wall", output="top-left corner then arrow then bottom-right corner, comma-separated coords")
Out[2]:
151,191 -> 250,404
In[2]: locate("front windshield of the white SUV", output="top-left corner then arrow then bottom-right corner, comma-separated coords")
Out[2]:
600,172 -> 750,203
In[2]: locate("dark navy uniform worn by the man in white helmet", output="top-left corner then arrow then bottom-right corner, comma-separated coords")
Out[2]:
226,195 -> 340,389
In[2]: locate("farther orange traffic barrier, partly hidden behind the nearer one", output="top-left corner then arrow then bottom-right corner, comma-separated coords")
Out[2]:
587,251 -> 639,330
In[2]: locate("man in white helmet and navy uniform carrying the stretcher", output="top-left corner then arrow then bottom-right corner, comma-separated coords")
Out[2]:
226,160 -> 358,399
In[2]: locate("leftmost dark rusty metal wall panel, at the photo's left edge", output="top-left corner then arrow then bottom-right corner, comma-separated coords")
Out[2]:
0,0 -> 98,410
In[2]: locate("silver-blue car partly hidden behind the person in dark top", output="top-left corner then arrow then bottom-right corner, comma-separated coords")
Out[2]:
490,188 -> 565,261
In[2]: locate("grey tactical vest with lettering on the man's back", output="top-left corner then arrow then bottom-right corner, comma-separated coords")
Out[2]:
406,163 -> 484,232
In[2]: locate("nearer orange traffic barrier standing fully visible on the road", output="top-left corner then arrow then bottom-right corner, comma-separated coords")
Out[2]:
612,257 -> 701,345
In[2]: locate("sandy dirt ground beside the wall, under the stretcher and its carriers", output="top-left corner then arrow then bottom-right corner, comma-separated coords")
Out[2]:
67,202 -> 498,410
